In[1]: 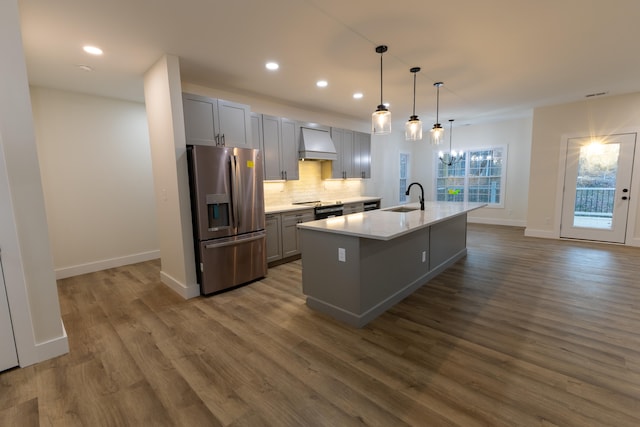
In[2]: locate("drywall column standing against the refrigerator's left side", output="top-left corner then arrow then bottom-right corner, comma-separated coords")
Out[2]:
144,55 -> 200,298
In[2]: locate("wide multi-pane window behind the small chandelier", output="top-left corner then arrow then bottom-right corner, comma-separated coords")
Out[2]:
435,147 -> 507,207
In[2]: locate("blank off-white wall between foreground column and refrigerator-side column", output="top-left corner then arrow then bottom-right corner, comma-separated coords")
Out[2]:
31,87 -> 159,278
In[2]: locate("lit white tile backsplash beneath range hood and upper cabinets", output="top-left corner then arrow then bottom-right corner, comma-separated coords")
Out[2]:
264,161 -> 362,206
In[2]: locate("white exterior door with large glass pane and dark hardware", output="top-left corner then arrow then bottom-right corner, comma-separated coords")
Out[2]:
560,133 -> 636,243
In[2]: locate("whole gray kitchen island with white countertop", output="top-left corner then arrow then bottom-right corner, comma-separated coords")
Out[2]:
298,202 -> 486,327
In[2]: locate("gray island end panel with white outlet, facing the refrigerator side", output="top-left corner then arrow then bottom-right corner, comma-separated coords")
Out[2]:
299,229 -> 361,316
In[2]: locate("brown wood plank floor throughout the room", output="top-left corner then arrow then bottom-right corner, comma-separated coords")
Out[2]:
0,225 -> 640,427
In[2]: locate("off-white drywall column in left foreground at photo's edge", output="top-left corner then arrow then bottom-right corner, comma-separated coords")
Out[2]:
0,0 -> 69,366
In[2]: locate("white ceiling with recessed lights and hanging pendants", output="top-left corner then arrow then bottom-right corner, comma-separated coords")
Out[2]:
18,0 -> 640,128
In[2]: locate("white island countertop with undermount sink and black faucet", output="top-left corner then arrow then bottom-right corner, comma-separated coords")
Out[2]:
298,202 -> 487,240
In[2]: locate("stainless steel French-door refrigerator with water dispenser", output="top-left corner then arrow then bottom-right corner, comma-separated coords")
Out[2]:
187,145 -> 267,295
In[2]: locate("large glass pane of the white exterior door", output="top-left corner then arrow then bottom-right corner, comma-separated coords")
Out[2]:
573,143 -> 620,230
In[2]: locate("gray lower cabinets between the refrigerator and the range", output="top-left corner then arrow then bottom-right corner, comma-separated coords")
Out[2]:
266,209 -> 315,262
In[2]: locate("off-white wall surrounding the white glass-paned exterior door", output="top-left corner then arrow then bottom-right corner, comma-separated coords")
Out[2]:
525,93 -> 640,246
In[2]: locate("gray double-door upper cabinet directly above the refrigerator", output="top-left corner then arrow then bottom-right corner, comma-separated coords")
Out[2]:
182,93 -> 254,148
